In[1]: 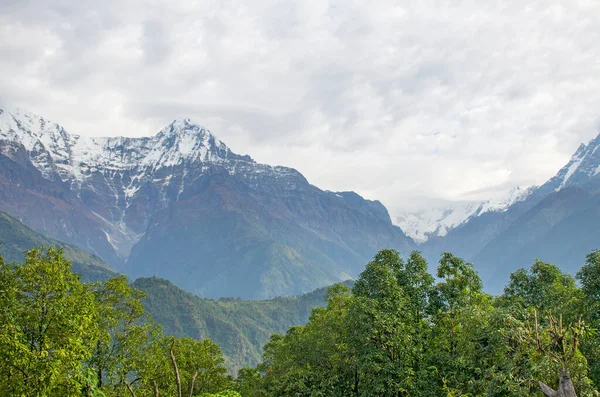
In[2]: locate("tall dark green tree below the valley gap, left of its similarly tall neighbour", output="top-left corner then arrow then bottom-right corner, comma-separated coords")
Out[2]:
348,250 -> 421,396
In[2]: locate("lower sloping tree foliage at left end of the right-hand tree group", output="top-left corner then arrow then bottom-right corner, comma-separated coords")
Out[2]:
254,284 -> 357,396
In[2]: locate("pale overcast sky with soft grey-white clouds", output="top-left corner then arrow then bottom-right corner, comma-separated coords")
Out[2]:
0,0 -> 600,216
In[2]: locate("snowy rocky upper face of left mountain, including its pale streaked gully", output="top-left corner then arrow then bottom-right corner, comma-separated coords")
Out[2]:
0,109 -> 299,257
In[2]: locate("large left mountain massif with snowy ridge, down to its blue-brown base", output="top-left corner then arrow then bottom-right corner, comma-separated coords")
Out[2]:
0,105 -> 416,298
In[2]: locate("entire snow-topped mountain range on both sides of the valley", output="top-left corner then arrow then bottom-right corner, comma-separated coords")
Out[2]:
0,103 -> 600,299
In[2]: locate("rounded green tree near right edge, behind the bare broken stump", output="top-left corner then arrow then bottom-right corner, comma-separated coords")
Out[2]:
493,260 -> 594,396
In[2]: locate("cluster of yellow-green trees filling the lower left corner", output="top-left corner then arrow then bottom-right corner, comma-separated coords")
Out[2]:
0,247 -> 236,397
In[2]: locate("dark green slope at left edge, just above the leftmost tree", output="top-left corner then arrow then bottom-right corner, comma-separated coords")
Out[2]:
0,212 -> 117,281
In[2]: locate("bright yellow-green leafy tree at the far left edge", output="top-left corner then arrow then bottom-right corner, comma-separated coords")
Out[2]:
0,248 -> 99,396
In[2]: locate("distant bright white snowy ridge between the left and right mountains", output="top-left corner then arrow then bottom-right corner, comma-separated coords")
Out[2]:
395,186 -> 537,243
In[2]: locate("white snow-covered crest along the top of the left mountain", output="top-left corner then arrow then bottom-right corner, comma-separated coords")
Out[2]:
0,108 -> 253,185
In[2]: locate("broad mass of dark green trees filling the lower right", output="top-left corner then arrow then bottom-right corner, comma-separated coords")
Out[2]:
234,250 -> 600,397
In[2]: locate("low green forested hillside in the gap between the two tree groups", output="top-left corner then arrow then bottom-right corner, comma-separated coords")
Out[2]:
133,277 -> 346,374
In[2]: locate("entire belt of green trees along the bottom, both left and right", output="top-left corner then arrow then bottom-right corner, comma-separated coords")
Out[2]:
0,247 -> 600,397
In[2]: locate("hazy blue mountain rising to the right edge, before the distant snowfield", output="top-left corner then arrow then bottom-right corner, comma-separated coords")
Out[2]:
419,135 -> 600,293
